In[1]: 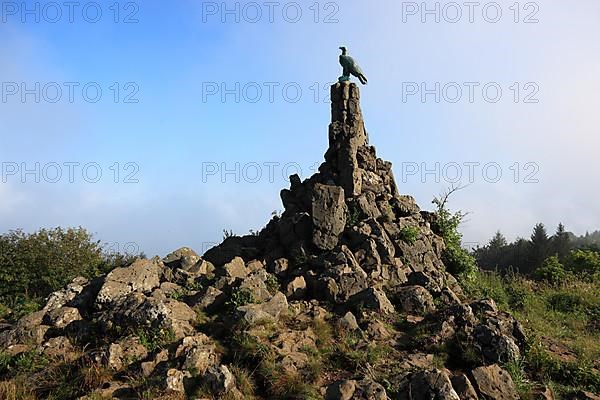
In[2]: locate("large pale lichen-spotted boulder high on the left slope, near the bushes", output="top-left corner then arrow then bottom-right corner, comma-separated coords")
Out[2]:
96,259 -> 163,309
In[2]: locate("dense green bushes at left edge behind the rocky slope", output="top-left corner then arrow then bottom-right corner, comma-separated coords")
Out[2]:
0,228 -> 144,319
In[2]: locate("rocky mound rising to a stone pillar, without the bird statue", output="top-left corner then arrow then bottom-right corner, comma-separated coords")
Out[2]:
0,82 -> 525,400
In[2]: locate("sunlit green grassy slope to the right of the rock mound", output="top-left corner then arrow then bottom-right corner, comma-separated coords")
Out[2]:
465,268 -> 600,398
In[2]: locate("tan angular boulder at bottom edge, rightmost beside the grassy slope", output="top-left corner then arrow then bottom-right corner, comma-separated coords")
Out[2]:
471,364 -> 519,400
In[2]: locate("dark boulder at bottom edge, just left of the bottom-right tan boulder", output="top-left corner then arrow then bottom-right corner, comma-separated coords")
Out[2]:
400,369 -> 461,400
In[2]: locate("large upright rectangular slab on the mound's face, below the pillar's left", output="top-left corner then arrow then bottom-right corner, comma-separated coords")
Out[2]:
312,184 -> 347,250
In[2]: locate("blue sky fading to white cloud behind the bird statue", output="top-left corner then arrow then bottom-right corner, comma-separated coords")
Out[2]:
0,0 -> 600,255
